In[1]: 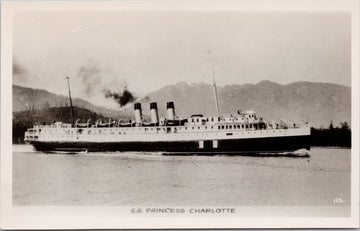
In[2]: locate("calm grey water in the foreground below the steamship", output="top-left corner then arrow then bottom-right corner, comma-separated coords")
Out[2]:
13,145 -> 350,206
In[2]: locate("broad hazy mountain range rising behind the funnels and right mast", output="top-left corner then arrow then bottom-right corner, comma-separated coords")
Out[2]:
136,81 -> 351,127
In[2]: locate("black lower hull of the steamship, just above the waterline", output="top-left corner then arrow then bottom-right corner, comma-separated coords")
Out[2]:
31,136 -> 310,154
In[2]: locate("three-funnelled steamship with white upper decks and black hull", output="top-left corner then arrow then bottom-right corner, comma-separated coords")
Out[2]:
25,77 -> 310,155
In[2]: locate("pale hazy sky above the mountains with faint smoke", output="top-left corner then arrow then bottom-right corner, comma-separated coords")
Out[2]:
13,10 -> 351,107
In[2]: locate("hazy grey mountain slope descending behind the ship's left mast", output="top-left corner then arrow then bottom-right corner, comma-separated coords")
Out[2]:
13,85 -> 132,118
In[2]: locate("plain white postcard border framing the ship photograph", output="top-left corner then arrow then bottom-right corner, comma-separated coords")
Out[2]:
1,0 -> 360,229
